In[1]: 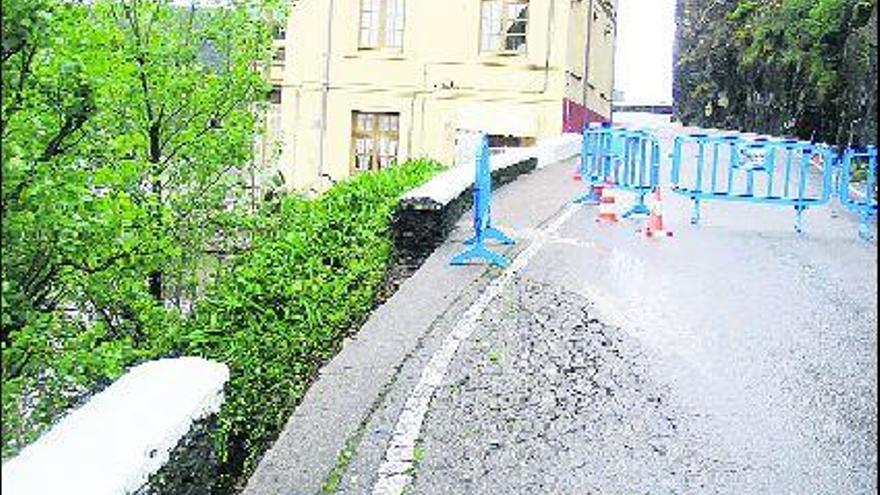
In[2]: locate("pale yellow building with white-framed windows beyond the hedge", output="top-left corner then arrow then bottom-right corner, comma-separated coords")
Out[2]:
270,0 -> 617,189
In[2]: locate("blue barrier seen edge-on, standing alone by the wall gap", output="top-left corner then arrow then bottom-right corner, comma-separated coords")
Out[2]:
450,134 -> 515,268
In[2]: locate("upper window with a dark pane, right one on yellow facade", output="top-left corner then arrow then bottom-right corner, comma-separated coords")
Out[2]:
480,0 -> 529,53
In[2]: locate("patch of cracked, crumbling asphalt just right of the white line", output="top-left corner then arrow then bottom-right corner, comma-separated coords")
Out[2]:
414,279 -> 743,494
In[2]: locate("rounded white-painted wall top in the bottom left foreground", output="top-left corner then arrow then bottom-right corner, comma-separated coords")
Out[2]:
2,357 -> 229,495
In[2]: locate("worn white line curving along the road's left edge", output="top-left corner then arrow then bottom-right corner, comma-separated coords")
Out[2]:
373,205 -> 578,495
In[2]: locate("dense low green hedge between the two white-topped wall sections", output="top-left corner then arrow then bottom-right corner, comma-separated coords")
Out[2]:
173,161 -> 438,486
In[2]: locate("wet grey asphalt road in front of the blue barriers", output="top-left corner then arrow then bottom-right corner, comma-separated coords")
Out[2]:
290,122 -> 877,495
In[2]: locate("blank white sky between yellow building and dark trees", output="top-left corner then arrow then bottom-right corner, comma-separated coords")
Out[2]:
614,0 -> 675,104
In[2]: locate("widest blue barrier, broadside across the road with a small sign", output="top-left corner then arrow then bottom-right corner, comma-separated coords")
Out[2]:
672,134 -> 835,232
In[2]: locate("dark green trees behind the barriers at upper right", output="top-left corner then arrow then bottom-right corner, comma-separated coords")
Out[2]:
673,0 -> 877,146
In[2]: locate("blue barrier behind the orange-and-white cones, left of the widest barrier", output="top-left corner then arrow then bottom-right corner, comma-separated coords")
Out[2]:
574,124 -> 660,218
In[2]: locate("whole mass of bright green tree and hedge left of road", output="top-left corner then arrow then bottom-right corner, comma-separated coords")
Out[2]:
0,0 -> 439,491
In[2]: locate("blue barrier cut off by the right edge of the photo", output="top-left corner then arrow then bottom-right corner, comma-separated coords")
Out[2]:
838,146 -> 877,240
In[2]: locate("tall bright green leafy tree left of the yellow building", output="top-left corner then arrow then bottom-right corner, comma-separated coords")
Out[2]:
2,0 -> 279,462
